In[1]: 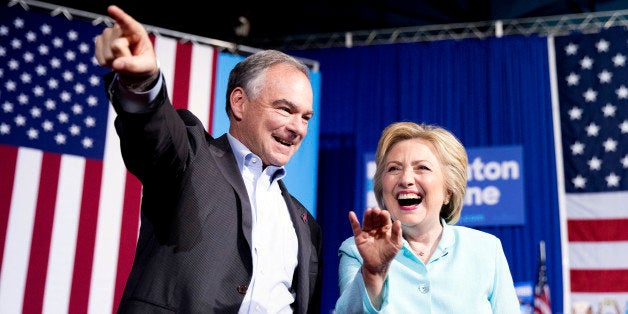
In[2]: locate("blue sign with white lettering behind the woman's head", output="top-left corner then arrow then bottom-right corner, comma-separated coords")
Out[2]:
364,146 -> 525,227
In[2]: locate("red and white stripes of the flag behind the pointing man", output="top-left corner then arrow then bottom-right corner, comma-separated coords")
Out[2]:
0,36 -> 218,313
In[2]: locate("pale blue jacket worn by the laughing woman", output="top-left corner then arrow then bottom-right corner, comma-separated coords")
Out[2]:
336,221 -> 521,314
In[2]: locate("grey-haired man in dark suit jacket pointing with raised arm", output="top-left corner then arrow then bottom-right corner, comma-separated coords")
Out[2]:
95,6 -> 322,313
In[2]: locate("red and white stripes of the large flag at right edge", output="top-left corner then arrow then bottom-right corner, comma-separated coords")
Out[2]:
565,192 -> 628,307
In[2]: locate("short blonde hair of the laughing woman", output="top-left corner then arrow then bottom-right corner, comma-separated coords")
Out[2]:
373,122 -> 468,225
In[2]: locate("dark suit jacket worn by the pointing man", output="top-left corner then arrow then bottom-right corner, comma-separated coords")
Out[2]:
106,74 -> 322,313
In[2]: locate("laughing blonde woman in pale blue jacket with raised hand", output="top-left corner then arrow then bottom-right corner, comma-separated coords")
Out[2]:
335,122 -> 520,314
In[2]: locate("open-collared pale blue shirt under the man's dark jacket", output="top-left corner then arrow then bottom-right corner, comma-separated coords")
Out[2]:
227,134 -> 298,314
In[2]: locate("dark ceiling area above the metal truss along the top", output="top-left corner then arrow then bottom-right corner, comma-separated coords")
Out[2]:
34,0 -> 628,48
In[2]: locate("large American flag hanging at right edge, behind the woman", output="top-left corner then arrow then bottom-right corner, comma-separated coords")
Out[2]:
554,28 -> 628,313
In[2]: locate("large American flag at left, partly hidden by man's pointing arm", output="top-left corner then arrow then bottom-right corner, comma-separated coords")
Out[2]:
0,5 -> 218,313
